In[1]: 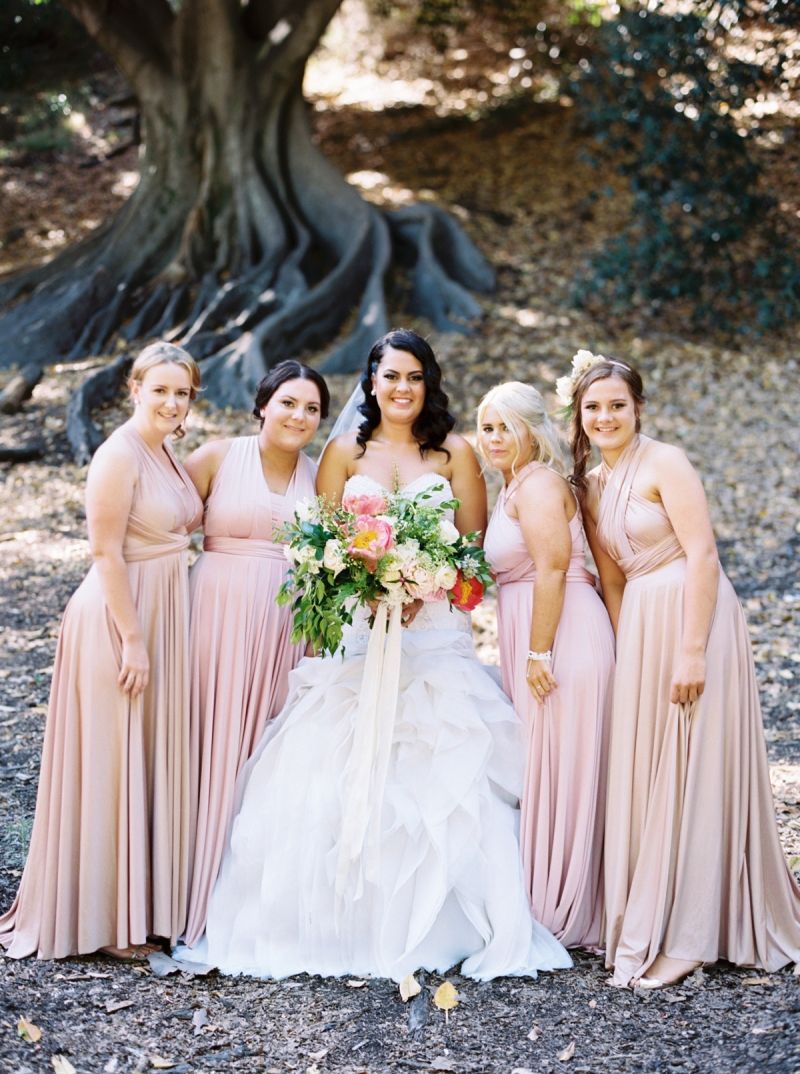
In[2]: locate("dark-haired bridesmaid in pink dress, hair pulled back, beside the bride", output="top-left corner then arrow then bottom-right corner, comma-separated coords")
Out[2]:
186,360 -> 329,946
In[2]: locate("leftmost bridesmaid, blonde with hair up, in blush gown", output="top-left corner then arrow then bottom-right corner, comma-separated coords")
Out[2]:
0,343 -> 202,960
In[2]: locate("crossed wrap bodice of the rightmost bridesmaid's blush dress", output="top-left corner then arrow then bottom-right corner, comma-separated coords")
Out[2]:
597,435 -> 685,579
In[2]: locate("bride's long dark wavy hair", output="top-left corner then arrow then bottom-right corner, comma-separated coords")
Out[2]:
355,329 -> 455,459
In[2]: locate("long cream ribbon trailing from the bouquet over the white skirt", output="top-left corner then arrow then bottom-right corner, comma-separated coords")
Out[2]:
335,601 -> 403,913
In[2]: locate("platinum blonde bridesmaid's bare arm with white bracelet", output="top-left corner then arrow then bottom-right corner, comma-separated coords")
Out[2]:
513,468 -> 572,701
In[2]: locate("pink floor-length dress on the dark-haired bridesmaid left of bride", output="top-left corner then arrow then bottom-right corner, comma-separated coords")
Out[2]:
186,436 -> 316,945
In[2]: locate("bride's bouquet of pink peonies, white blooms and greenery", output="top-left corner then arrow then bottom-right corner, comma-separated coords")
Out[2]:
277,489 -> 491,653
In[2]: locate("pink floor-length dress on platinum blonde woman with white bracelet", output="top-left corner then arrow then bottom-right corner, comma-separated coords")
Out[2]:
484,462 -> 614,947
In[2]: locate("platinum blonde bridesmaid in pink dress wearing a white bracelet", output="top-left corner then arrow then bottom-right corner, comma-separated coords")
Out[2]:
478,381 -> 614,948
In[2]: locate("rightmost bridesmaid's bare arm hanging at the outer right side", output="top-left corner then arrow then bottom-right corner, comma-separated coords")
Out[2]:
651,444 -> 719,705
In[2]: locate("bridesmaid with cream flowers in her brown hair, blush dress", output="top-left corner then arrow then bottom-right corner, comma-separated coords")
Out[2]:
559,352 -> 800,988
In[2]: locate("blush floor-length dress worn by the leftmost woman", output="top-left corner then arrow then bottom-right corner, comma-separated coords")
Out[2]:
0,423 -> 202,958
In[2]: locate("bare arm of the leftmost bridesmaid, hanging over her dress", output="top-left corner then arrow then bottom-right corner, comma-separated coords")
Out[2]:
86,446 -> 149,697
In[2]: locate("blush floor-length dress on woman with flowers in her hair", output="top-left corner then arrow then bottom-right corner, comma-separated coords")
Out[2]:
597,436 -> 800,985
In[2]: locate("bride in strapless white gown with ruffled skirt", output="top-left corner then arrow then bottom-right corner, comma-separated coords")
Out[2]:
176,330 -> 571,981
